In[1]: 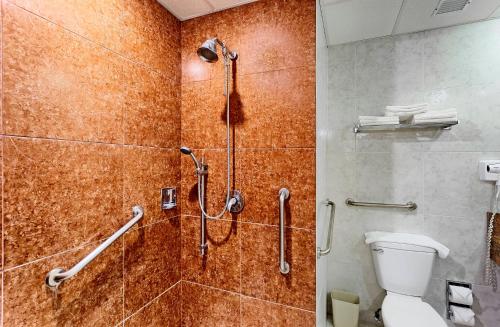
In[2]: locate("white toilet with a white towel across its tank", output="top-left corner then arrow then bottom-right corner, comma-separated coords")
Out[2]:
365,232 -> 449,327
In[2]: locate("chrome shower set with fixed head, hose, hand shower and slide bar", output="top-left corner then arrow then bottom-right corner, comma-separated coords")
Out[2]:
180,38 -> 244,256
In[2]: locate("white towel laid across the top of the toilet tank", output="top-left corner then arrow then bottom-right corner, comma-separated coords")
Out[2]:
365,231 -> 450,259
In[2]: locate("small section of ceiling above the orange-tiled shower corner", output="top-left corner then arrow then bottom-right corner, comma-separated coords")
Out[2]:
158,0 -> 257,20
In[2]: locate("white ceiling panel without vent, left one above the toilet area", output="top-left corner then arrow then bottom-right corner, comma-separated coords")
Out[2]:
322,0 -> 403,45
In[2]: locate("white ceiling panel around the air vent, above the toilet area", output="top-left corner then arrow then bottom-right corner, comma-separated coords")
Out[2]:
394,0 -> 500,34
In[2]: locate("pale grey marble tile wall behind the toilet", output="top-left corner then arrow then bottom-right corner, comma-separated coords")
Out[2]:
327,20 -> 500,327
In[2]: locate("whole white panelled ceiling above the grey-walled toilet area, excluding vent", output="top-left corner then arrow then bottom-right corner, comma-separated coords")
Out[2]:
320,0 -> 500,45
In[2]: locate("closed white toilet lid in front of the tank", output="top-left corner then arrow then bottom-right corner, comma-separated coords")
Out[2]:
382,293 -> 447,327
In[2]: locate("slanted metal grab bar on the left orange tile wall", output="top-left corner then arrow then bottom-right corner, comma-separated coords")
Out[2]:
45,206 -> 144,288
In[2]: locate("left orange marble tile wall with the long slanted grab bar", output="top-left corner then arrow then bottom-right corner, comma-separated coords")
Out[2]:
0,0 -> 181,326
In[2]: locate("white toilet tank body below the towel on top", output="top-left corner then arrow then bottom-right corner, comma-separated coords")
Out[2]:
370,242 -> 436,296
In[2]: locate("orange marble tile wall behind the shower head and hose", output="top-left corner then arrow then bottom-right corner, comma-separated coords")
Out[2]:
181,0 -> 316,326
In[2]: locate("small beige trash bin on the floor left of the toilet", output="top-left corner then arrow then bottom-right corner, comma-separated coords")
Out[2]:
331,290 -> 359,327
